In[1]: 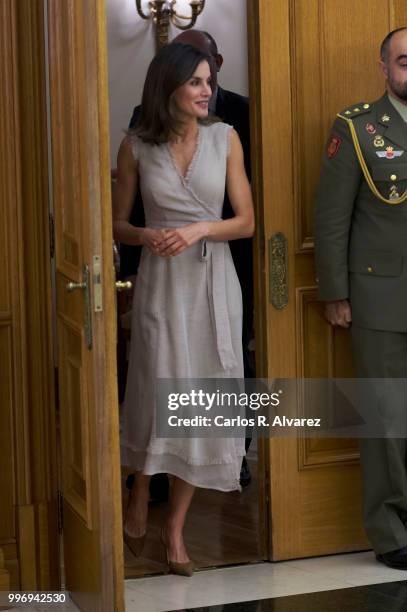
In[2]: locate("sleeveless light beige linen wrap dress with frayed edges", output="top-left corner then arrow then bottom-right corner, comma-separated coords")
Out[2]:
121,123 -> 245,491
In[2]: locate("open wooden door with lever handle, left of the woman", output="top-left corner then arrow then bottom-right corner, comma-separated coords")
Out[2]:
47,0 -> 124,612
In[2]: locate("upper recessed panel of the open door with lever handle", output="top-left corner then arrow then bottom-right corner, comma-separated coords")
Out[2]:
49,0 -> 84,282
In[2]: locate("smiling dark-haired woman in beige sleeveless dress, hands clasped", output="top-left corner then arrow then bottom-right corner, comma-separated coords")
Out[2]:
114,43 -> 254,576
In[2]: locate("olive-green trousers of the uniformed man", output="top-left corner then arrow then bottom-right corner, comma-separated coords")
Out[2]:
352,325 -> 407,553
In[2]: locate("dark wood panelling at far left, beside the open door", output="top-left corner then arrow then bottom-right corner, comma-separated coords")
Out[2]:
0,0 -> 60,590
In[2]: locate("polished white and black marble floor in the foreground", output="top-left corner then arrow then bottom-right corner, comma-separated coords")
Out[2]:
125,552 -> 407,612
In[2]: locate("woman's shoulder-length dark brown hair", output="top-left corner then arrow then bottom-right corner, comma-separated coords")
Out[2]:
131,43 -> 216,144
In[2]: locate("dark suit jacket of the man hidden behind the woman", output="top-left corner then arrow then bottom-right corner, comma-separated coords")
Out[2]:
120,87 -> 253,334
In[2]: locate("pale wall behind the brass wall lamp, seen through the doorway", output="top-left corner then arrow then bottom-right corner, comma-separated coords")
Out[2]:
106,0 -> 248,167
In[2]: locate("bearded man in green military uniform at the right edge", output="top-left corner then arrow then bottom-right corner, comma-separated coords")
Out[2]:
315,28 -> 407,569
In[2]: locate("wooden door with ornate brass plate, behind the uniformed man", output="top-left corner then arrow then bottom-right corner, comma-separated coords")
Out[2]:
249,0 -> 407,560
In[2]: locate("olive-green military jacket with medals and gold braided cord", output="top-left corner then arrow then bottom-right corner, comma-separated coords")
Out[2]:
315,94 -> 407,331
